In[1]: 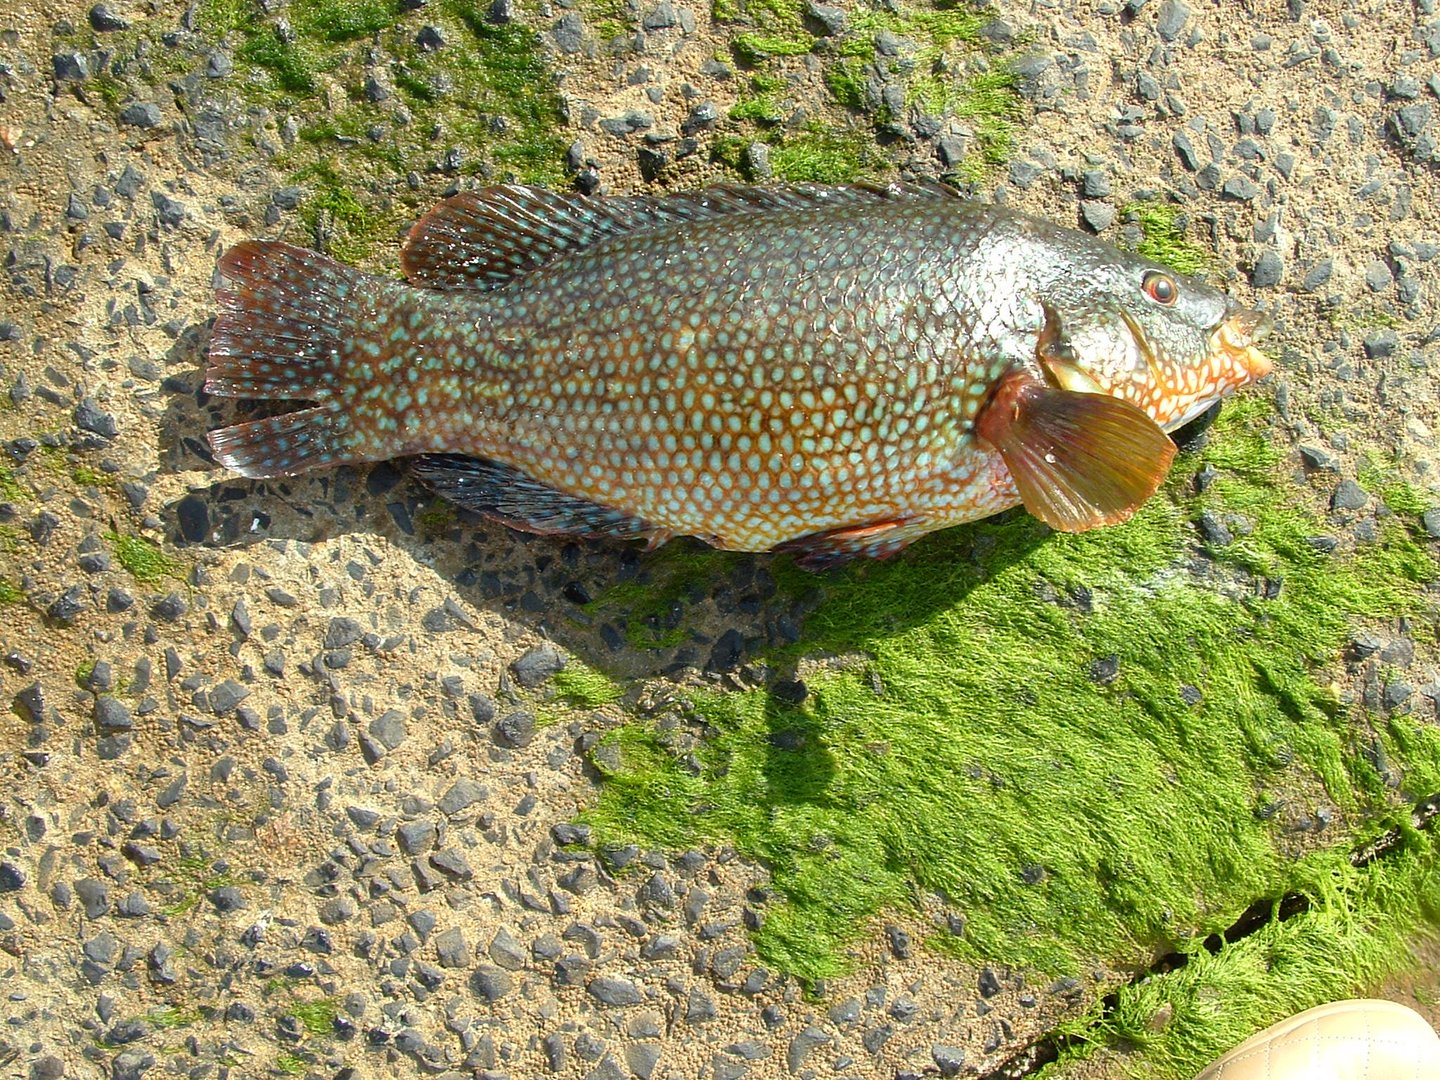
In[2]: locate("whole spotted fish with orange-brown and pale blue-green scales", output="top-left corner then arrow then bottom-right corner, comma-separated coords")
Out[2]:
204,183 -> 1272,569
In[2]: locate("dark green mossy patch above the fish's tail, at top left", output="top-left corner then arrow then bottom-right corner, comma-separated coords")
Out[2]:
197,0 -> 564,262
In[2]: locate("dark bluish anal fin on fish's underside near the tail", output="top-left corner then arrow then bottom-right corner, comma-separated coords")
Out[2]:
410,454 -> 670,546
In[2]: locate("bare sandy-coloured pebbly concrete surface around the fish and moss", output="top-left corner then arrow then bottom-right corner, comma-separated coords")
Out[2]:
0,0 -> 1440,1077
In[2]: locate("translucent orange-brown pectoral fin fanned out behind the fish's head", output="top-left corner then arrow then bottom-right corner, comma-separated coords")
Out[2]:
975,374 -> 1175,533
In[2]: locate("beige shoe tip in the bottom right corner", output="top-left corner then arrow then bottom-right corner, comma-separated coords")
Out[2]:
1195,999 -> 1440,1080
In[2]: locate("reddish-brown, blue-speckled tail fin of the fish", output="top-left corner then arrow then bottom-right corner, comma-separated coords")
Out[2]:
204,240 -> 399,478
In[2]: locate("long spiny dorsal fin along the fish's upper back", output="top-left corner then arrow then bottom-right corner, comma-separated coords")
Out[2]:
400,183 -> 958,289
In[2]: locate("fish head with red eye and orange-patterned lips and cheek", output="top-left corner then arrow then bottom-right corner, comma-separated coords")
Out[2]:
1037,251 -> 1272,431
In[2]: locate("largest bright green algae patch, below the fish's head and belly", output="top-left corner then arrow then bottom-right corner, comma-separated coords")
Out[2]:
586,400 -> 1440,979
